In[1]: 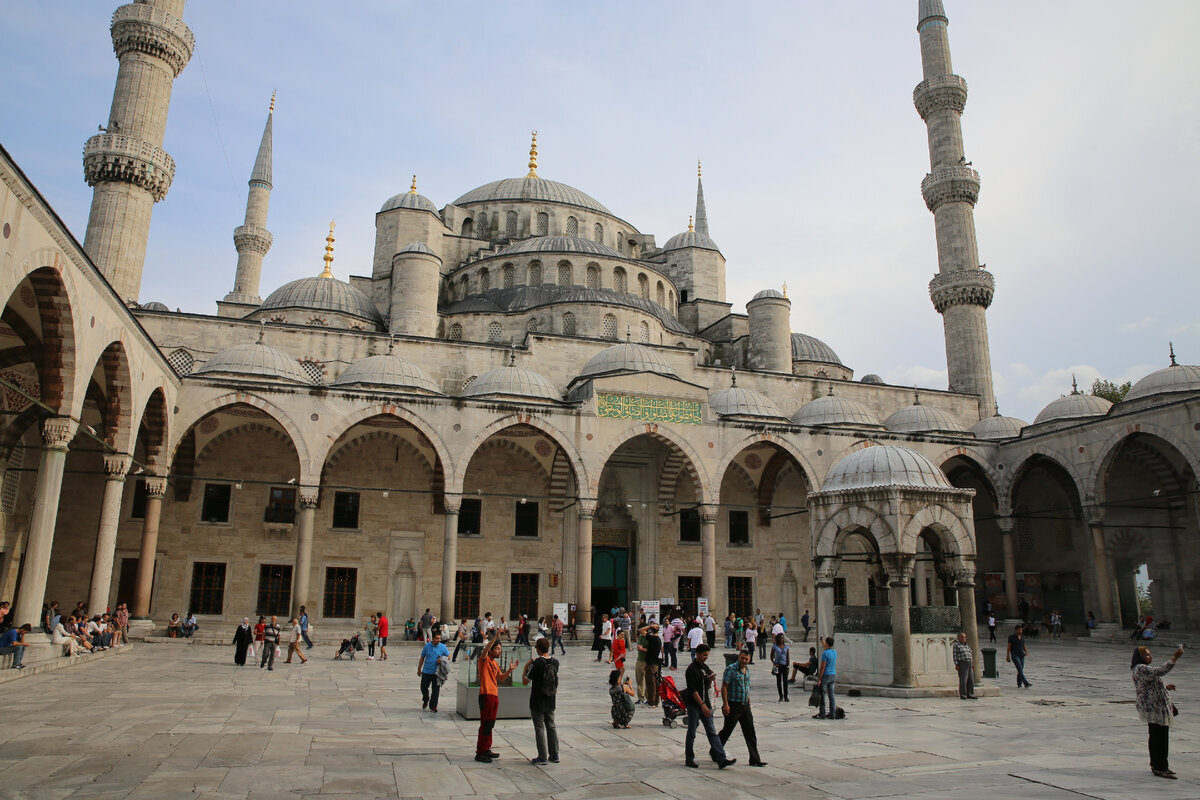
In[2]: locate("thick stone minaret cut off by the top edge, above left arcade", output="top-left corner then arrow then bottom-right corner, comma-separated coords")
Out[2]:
83,0 -> 196,302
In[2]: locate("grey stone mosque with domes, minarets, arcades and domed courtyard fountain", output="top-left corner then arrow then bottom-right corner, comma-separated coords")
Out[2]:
0,0 -> 1200,686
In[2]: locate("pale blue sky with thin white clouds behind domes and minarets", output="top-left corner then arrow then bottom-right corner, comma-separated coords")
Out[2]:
0,0 -> 1200,421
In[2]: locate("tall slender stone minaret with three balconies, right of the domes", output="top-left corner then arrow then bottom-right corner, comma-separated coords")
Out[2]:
912,0 -> 996,419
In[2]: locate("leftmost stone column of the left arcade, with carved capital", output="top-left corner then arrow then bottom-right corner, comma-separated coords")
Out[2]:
12,416 -> 77,625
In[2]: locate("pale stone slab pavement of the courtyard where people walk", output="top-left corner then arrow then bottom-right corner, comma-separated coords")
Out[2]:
0,642 -> 1200,800
